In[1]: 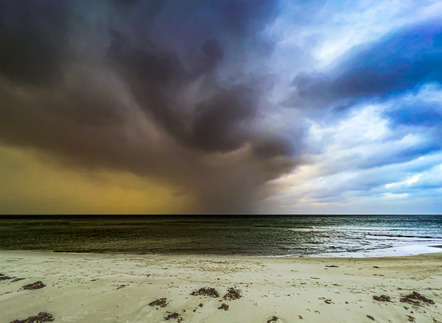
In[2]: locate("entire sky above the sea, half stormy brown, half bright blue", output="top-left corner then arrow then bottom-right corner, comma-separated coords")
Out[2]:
0,0 -> 442,214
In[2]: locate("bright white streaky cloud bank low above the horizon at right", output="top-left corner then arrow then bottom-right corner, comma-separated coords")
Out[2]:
265,97 -> 442,213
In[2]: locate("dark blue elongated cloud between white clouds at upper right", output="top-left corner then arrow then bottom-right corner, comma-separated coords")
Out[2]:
293,22 -> 442,108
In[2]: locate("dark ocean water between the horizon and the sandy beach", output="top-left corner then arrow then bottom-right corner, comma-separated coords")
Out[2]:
0,215 -> 442,256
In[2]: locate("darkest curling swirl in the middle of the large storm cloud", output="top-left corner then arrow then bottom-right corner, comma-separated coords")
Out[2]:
108,32 -> 257,152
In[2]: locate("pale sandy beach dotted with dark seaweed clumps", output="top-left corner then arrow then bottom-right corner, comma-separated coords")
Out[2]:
0,251 -> 442,323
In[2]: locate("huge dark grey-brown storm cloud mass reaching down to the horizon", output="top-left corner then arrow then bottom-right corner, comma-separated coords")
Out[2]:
0,0 -> 294,212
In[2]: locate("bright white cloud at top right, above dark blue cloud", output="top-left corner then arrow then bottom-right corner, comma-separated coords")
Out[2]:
268,0 -> 442,67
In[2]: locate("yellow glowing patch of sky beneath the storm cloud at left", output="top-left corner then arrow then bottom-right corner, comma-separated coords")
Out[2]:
0,146 -> 195,214
